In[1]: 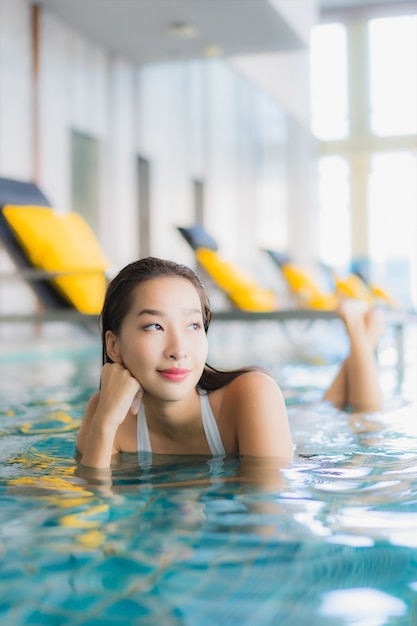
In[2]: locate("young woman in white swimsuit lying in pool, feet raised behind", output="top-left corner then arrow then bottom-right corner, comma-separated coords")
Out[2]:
77,257 -> 378,468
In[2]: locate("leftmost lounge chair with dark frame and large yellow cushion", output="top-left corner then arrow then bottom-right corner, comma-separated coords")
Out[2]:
0,173 -> 108,324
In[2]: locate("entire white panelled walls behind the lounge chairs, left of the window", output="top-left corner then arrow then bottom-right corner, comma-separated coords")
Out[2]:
0,0 -> 315,322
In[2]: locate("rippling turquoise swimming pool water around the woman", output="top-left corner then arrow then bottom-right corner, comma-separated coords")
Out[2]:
0,320 -> 417,626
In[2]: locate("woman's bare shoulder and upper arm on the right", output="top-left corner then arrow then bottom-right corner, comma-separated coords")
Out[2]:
224,372 -> 294,460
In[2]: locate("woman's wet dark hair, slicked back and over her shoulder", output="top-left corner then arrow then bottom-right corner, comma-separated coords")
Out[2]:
100,257 -> 260,392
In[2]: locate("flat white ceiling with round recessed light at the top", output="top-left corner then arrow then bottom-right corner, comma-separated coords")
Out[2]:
28,0 -> 412,64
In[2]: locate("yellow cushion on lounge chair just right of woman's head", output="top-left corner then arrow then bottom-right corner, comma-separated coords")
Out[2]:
196,248 -> 276,311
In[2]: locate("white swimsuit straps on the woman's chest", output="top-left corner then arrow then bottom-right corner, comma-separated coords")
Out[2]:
137,394 -> 226,465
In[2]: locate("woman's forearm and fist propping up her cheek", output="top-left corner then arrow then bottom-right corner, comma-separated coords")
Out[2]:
77,363 -> 141,468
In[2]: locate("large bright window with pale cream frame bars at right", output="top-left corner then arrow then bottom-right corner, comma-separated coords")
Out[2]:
311,14 -> 417,308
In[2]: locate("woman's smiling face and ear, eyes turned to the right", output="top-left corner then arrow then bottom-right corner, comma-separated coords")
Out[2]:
106,276 -> 208,401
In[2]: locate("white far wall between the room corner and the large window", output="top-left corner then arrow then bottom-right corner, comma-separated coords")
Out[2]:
138,60 -> 298,269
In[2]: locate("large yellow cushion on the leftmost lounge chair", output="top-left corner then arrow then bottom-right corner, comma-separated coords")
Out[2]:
3,205 -> 109,314
